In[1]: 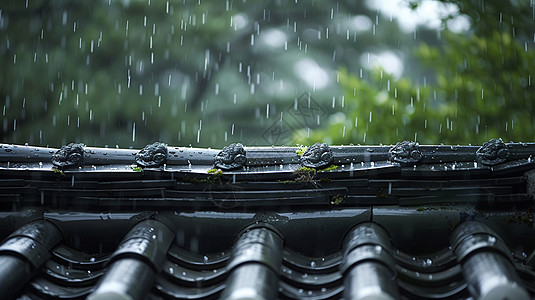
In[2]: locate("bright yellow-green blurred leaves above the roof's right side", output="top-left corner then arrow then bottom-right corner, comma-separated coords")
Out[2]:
298,0 -> 535,144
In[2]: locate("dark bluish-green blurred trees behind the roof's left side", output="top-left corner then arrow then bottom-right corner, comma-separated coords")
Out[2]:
0,0 -> 416,147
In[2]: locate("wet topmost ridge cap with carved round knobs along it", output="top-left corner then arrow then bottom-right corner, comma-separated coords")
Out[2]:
0,139 -> 535,171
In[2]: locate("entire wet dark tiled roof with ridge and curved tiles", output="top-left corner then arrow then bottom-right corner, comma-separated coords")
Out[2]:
0,140 -> 535,300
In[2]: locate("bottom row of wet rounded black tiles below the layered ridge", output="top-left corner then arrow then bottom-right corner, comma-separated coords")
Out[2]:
0,210 -> 535,299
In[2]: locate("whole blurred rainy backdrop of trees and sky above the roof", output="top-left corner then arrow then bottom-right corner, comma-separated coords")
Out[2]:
0,0 -> 535,148
